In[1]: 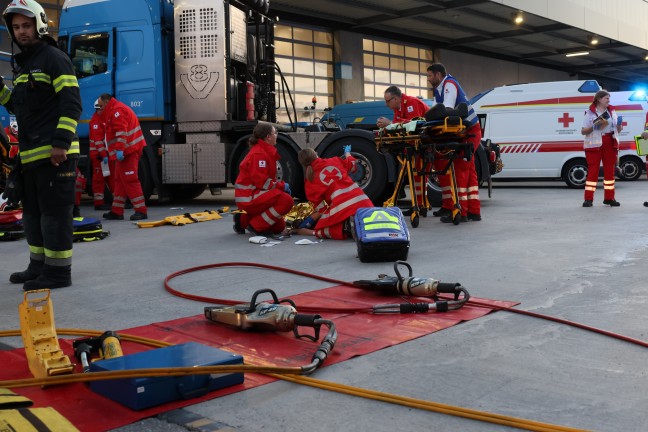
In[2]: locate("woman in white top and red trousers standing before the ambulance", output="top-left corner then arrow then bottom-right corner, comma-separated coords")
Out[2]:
581,90 -> 623,207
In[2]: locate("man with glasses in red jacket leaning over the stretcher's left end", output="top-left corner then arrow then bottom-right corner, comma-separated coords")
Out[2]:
376,86 -> 430,208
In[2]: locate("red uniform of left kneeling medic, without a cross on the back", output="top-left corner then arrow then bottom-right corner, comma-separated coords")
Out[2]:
234,139 -> 293,234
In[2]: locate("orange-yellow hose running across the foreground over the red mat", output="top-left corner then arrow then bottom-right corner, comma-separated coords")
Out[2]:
0,329 -> 584,432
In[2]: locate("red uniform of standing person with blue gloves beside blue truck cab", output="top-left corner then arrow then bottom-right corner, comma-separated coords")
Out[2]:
102,98 -> 147,215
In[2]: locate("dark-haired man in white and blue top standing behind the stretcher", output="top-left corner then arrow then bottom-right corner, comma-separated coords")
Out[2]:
427,63 -> 482,222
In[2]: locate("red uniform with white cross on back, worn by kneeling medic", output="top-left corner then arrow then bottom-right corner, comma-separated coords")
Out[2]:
306,156 -> 373,240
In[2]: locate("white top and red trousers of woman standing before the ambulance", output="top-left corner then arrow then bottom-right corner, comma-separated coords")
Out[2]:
583,104 -> 619,201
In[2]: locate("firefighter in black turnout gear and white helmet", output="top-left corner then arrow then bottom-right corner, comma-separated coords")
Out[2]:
0,0 -> 82,291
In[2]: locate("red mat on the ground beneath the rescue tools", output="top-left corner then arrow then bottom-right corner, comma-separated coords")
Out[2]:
0,287 -> 517,432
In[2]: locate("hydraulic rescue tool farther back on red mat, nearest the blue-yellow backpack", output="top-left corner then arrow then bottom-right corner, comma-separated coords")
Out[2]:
353,261 -> 470,313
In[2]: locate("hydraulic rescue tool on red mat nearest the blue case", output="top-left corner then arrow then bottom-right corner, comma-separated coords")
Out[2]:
205,289 -> 337,374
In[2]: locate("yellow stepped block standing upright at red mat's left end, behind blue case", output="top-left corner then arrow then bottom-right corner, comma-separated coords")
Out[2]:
18,289 -> 74,378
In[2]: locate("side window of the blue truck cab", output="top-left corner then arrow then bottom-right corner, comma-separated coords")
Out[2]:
70,33 -> 110,78
